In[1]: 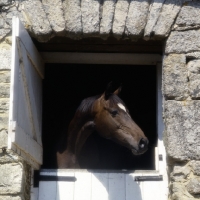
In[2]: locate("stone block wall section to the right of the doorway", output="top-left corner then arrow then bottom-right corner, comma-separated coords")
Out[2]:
163,1 -> 200,200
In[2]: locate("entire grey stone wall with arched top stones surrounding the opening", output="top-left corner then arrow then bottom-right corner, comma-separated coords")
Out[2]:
0,0 -> 200,200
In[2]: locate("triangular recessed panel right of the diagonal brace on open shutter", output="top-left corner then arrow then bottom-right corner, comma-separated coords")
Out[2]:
17,38 -> 42,145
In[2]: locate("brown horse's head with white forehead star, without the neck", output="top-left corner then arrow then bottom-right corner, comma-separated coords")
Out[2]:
93,83 -> 148,155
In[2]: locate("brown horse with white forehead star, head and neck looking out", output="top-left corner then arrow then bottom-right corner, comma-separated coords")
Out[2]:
56,83 -> 148,169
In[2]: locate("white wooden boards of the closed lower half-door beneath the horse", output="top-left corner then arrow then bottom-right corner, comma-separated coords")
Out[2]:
39,169 -> 167,200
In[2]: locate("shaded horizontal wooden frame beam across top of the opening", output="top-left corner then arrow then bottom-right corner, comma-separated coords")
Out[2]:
41,52 -> 162,65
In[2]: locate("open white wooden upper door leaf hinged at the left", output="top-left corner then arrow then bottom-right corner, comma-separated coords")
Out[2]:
8,17 -> 44,169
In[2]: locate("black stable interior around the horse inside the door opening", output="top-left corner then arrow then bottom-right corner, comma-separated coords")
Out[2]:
42,64 -> 157,170
